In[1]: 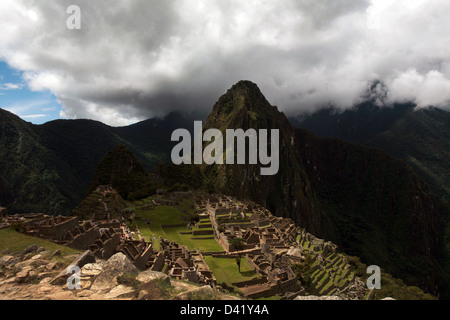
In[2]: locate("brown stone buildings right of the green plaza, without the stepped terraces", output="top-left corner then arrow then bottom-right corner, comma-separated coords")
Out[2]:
196,196 -> 302,298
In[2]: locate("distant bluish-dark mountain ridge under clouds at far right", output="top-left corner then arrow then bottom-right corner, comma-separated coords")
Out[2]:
289,101 -> 450,208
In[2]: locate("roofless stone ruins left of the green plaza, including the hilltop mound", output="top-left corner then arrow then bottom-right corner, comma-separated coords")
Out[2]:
1,186 -> 216,286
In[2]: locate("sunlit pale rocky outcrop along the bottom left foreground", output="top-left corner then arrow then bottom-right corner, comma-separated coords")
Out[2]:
0,246 -> 238,300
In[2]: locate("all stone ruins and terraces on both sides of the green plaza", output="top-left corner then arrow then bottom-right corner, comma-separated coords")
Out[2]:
2,186 -> 366,298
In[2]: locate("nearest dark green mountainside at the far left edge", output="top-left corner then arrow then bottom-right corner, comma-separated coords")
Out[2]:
0,110 -> 79,213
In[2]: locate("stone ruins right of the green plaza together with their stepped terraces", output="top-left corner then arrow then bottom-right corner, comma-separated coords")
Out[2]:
195,192 -> 364,298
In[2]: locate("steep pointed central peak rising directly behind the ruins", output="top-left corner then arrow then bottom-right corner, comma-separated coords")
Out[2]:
202,81 -> 324,236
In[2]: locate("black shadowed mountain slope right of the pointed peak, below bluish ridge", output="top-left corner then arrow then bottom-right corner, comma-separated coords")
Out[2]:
297,130 -> 444,292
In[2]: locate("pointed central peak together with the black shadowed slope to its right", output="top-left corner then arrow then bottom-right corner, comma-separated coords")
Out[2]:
201,81 -> 443,292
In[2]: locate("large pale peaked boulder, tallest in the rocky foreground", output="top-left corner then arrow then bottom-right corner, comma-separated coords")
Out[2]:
91,252 -> 139,291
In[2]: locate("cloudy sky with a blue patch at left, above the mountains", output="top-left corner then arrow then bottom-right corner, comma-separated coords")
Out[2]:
0,0 -> 450,126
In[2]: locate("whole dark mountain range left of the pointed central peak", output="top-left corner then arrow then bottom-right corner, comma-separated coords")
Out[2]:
0,109 -> 199,214
